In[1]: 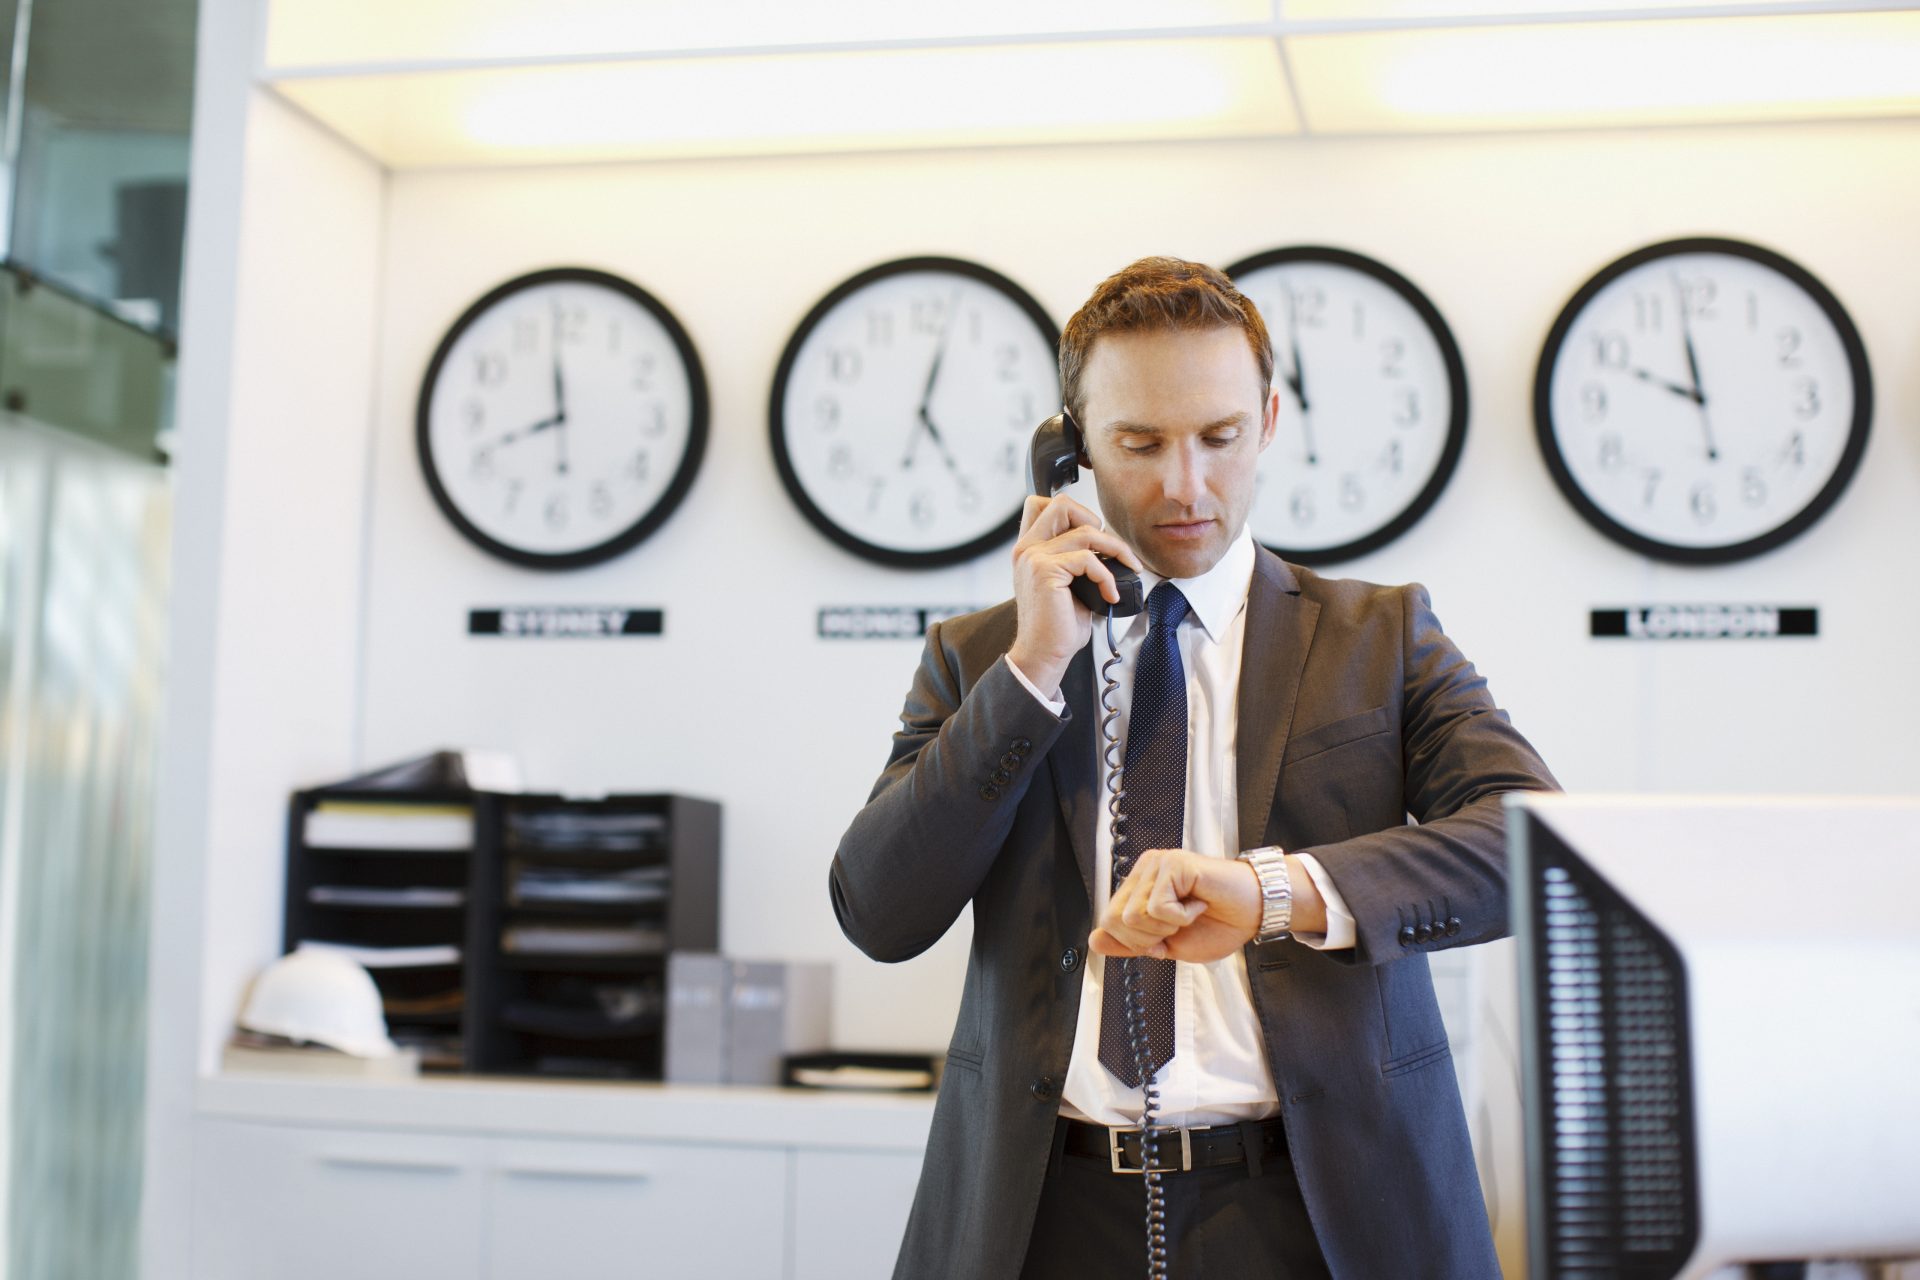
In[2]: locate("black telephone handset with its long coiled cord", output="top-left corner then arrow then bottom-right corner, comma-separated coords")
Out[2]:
1029,411 -> 1167,1280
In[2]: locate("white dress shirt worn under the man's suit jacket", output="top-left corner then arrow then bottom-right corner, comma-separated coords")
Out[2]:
1008,528 -> 1354,1126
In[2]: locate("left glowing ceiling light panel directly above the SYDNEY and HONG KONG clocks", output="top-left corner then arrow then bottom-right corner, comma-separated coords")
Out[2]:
275,38 -> 1296,169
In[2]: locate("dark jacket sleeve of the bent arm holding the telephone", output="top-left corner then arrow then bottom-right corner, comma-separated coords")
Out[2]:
828,624 -> 1071,961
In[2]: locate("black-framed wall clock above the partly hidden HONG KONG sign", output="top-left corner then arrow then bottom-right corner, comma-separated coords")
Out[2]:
768,257 -> 1060,568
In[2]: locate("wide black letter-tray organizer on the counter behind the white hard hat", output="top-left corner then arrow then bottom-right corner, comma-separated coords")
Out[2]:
284,771 -> 720,1080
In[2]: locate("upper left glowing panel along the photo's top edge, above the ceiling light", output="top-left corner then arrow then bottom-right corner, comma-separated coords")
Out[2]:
265,0 -> 1271,71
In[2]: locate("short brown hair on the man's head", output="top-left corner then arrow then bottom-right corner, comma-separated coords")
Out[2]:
1060,257 -> 1273,426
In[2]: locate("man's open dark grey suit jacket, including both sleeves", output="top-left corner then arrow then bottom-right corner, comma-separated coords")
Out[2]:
829,551 -> 1555,1280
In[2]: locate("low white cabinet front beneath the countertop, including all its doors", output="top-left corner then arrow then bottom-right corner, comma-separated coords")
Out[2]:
192,1115 -> 920,1280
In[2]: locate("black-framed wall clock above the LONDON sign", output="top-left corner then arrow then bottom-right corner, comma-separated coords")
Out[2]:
1534,238 -> 1874,564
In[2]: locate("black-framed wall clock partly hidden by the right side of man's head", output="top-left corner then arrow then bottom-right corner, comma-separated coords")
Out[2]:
1227,246 -> 1467,564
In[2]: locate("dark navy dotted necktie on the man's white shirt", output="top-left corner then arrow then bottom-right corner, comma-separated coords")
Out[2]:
1100,581 -> 1188,1088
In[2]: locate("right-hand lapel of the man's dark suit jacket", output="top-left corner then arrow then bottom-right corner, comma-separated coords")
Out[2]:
1235,547 -> 1319,848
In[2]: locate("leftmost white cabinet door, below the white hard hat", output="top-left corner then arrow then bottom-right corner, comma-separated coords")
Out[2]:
194,1121 -> 484,1280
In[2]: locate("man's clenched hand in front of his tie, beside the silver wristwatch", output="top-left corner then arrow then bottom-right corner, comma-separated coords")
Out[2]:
1089,848 -> 1261,963
